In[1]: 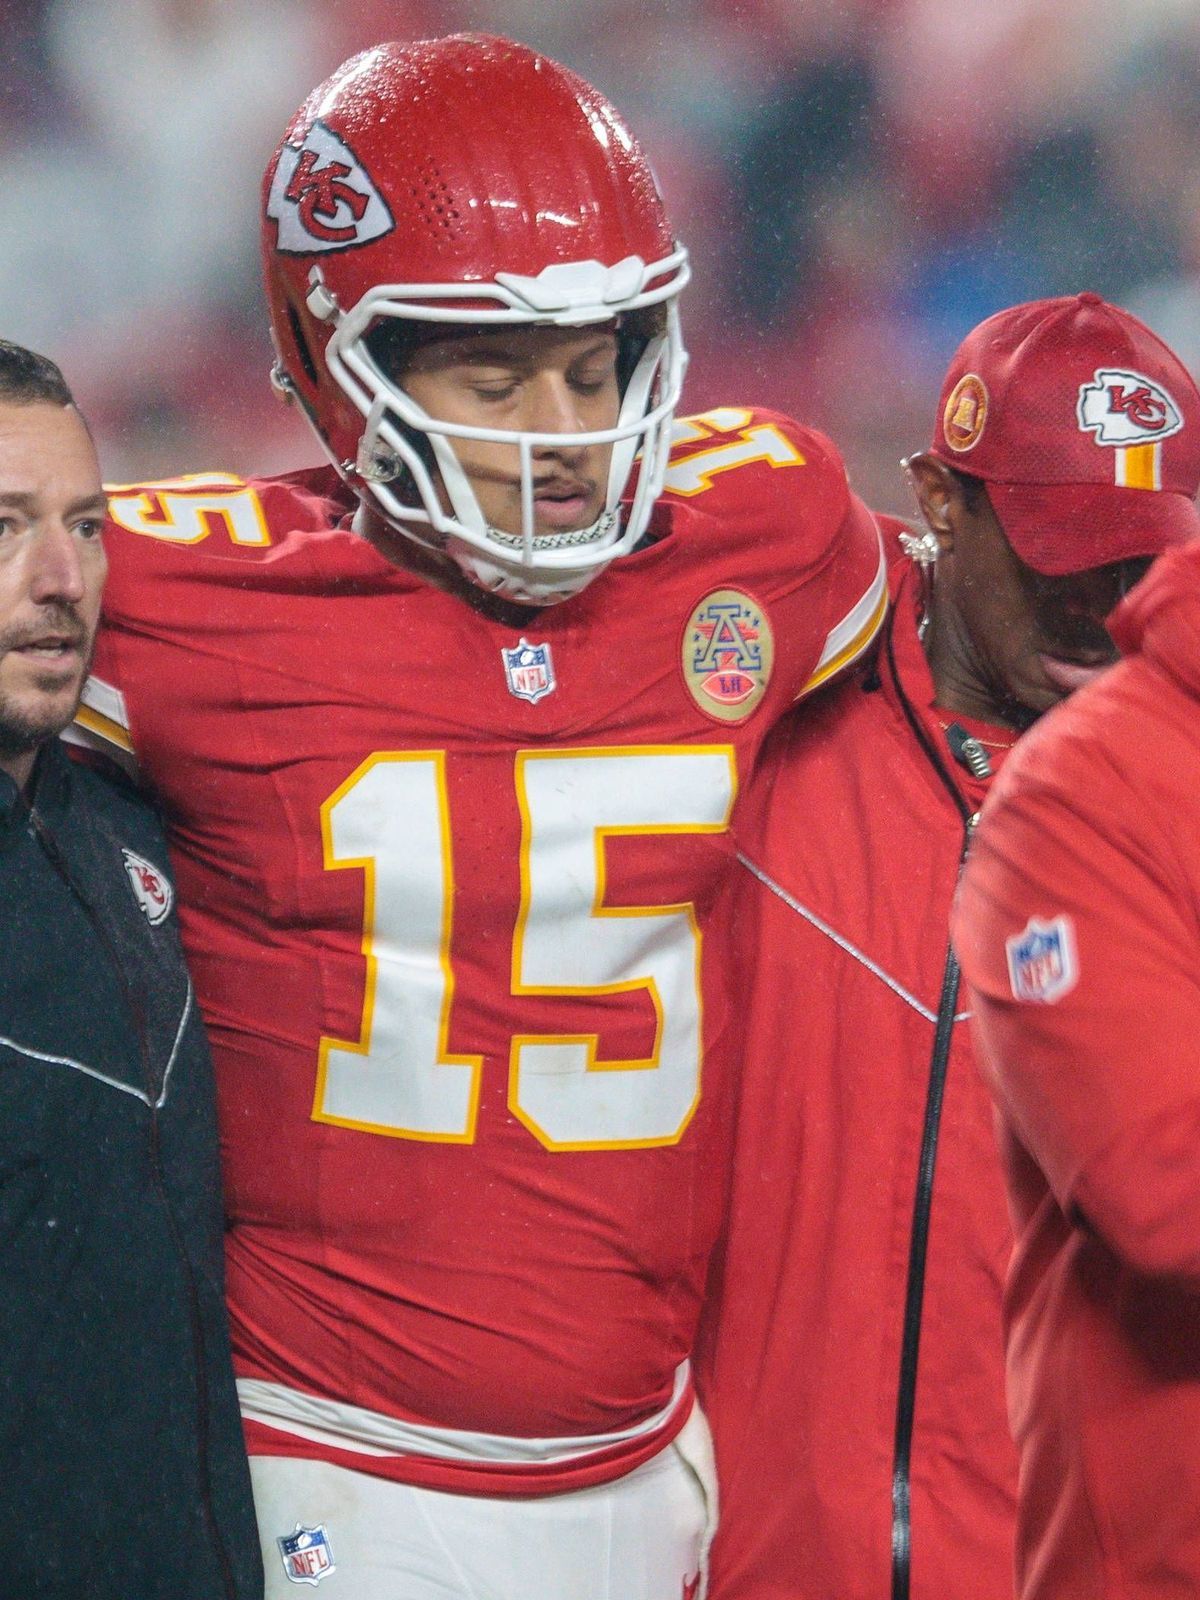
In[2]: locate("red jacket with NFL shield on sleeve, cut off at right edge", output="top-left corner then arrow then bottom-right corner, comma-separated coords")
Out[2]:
955,547 -> 1200,1600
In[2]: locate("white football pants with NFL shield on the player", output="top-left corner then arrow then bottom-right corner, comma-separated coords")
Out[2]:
250,1408 -> 717,1600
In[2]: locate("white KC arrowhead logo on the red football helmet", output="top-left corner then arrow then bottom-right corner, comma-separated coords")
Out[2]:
267,122 -> 395,256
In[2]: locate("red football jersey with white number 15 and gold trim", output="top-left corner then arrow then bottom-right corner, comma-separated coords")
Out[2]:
80,408 -> 885,1493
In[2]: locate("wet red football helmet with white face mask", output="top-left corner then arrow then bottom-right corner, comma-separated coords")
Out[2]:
262,34 -> 690,605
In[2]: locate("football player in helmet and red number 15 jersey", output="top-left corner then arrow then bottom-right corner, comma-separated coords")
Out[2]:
72,35 -> 885,1600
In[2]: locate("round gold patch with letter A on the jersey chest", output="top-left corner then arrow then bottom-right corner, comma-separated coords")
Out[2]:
682,589 -> 774,722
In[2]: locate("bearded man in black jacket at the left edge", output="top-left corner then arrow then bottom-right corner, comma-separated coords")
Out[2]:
0,342 -> 262,1600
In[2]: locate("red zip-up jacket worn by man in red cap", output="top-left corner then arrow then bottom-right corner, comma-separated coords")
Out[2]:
698,563 -> 1016,1600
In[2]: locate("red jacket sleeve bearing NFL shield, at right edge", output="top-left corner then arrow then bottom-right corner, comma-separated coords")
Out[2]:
954,730 -> 1200,1288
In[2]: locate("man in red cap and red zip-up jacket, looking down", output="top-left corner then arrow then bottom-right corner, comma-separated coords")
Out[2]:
699,294 -> 1200,1600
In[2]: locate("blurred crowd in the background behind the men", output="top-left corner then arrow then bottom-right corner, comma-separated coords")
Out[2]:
0,0 -> 1200,512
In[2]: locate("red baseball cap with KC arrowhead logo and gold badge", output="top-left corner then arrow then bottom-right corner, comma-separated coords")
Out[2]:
931,293 -> 1200,574
